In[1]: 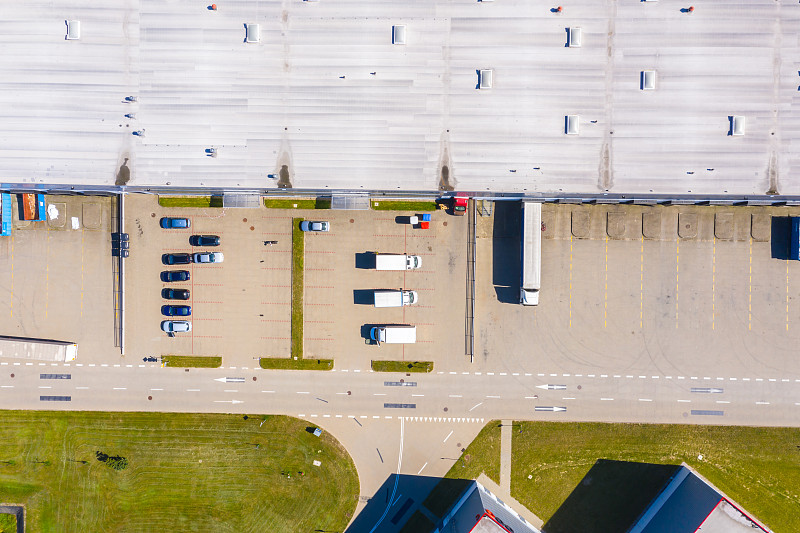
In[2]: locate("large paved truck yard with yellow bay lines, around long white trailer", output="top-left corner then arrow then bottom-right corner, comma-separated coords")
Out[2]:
475,203 -> 800,377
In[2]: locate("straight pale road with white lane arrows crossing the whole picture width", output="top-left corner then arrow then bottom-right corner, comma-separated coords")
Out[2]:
7,362 -> 800,426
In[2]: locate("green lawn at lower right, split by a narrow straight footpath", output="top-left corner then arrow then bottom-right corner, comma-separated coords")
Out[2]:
447,420 -> 800,532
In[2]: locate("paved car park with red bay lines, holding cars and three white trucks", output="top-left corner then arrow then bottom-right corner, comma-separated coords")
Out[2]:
126,195 -> 466,369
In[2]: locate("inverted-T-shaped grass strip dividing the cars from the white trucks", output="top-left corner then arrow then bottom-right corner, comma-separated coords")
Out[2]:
258,218 -> 333,370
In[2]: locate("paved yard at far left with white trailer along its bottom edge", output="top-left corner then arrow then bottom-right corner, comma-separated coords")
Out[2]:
0,195 -> 119,363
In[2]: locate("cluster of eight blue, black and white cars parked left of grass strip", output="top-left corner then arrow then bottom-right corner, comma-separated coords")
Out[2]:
160,217 -> 220,337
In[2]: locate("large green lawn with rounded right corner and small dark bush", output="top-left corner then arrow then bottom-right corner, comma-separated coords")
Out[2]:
0,411 -> 359,533
